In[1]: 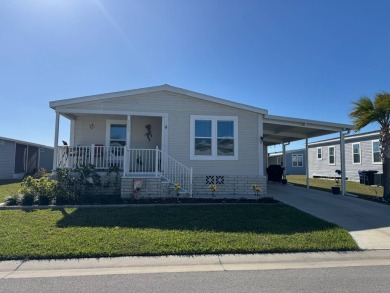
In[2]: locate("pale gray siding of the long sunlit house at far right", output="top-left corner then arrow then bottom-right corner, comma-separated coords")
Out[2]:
309,132 -> 383,181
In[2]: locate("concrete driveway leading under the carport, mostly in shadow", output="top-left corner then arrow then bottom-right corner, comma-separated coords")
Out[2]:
267,182 -> 390,249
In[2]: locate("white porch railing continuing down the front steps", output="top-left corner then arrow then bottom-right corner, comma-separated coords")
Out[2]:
57,145 -> 192,195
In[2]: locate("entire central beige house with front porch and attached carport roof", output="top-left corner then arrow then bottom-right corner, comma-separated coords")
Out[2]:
50,85 -> 353,197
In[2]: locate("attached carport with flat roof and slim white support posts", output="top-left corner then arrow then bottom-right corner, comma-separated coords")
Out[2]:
261,115 -> 354,195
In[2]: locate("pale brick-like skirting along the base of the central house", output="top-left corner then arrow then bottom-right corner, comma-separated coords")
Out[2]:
121,175 -> 267,198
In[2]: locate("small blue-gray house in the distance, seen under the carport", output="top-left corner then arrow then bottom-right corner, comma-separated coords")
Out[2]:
268,149 -> 306,175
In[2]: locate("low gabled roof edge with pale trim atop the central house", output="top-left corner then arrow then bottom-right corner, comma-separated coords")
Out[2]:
49,84 -> 268,114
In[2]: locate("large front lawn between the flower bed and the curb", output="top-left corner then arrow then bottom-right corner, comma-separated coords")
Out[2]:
0,204 -> 358,260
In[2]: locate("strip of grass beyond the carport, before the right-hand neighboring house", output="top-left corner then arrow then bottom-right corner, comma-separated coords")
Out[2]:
287,175 -> 383,197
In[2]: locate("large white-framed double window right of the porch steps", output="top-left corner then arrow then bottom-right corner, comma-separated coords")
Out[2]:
190,115 -> 238,160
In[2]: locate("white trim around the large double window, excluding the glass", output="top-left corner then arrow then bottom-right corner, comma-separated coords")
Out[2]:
190,115 -> 238,161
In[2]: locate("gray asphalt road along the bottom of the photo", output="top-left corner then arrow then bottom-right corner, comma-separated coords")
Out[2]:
0,266 -> 390,293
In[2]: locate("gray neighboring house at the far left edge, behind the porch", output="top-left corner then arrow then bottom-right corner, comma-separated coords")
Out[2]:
0,137 -> 53,179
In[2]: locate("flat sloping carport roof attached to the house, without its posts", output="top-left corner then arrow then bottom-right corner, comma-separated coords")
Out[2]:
263,115 -> 354,146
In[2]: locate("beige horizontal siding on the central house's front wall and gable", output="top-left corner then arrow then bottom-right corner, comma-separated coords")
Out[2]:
66,92 -> 259,175
